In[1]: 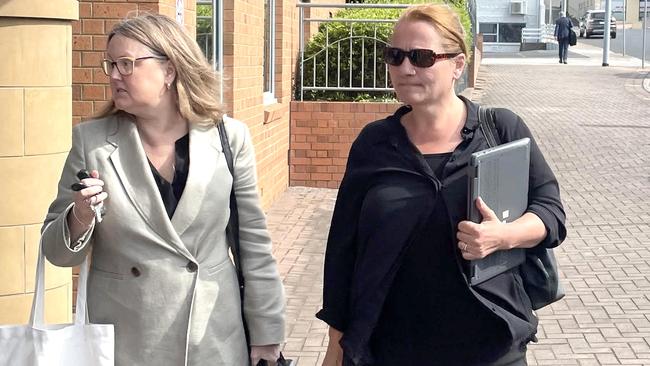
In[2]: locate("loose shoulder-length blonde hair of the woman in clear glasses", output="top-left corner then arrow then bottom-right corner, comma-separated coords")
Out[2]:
96,14 -> 223,125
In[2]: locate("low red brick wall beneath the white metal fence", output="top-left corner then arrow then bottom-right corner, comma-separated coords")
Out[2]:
289,102 -> 401,188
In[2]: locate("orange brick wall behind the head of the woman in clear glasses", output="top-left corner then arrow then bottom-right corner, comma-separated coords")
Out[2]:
72,0 -> 196,124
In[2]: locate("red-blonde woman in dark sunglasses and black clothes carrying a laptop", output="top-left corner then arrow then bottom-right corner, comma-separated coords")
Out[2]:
317,5 -> 566,366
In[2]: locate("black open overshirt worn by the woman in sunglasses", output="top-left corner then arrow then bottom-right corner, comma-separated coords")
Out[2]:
317,98 -> 566,365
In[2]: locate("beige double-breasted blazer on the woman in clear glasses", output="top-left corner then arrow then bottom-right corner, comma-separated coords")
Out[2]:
42,116 -> 284,366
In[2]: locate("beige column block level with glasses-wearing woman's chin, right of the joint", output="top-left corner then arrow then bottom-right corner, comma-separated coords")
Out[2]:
25,87 -> 72,155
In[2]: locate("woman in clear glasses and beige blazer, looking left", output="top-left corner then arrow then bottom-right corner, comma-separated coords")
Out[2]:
42,15 -> 284,366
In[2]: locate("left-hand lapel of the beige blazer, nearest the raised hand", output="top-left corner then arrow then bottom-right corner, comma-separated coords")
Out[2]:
107,117 -> 193,259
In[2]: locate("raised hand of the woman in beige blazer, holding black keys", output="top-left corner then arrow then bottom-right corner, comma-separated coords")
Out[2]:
68,170 -> 108,241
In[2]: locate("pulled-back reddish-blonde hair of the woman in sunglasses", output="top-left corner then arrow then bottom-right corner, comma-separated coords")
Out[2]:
395,4 -> 469,57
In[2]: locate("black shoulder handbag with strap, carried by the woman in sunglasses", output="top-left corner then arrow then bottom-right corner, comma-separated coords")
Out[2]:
478,106 -> 565,310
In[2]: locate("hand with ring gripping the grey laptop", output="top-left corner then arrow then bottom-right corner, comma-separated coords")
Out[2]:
456,197 -> 509,260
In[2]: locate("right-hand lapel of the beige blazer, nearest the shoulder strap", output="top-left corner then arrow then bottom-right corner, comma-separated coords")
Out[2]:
171,124 -> 223,236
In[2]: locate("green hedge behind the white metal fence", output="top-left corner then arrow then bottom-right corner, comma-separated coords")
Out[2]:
296,0 -> 472,101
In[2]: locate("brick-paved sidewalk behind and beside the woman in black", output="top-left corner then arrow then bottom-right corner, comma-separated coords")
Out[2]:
268,46 -> 650,366
